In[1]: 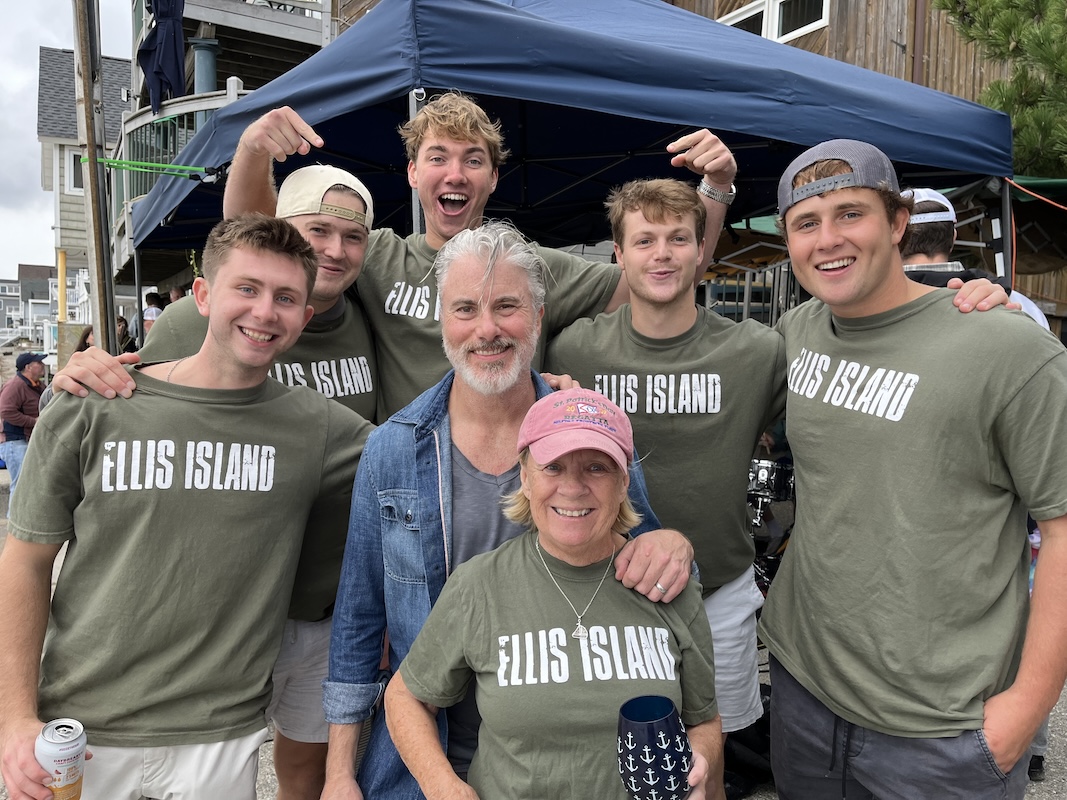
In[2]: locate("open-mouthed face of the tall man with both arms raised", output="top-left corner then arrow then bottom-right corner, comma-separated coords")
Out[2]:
408,134 -> 497,250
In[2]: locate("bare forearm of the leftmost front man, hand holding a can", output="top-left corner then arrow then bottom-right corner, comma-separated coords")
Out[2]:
0,535 -> 60,800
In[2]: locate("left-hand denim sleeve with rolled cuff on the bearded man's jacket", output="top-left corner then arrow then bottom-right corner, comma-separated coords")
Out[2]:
322,435 -> 386,724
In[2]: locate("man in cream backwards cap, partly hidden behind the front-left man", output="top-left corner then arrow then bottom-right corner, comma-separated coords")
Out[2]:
141,164 -> 378,800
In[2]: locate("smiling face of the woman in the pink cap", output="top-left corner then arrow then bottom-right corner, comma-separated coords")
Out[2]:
521,449 -> 630,565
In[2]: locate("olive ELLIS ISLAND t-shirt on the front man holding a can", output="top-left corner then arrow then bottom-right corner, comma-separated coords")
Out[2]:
10,370 -> 369,747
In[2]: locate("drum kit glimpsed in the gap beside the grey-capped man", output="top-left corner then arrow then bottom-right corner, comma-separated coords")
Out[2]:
748,459 -> 796,594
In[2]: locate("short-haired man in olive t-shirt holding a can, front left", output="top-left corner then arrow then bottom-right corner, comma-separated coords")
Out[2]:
0,217 -> 370,800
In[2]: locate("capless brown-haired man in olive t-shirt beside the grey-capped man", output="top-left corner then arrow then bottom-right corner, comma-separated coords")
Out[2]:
545,179 -> 785,733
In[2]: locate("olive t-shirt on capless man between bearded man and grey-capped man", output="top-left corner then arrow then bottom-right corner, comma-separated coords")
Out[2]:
545,305 -> 785,594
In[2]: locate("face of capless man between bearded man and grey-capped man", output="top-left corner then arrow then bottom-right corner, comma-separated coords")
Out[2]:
615,209 -> 704,306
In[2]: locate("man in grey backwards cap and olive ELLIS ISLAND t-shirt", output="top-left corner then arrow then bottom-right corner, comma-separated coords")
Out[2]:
761,140 -> 1067,800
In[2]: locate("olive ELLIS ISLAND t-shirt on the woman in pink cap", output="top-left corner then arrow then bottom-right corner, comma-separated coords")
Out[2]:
400,533 -> 718,800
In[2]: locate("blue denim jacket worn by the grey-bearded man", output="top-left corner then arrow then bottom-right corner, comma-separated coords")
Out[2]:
322,371 -> 660,800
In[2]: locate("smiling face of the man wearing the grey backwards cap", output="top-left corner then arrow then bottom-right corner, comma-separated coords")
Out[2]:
784,189 -> 910,317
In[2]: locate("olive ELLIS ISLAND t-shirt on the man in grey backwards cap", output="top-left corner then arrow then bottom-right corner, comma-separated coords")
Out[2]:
761,289 -> 1067,737
